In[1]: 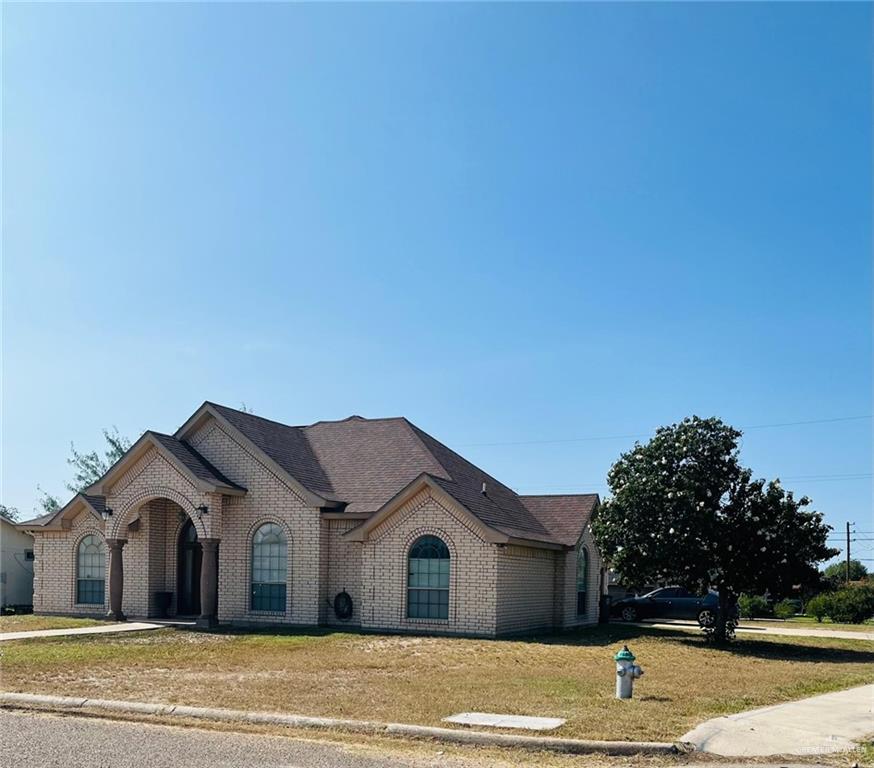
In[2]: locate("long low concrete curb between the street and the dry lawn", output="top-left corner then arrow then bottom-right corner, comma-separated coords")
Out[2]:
0,692 -> 690,755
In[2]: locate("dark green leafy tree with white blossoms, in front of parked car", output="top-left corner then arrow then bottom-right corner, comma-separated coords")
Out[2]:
592,416 -> 835,641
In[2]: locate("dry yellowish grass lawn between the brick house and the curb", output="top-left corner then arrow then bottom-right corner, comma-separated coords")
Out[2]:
2,625 -> 874,740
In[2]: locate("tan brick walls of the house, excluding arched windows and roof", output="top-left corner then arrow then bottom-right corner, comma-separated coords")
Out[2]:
34,420 -> 600,636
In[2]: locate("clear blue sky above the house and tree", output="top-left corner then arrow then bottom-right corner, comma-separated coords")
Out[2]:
2,3 -> 874,565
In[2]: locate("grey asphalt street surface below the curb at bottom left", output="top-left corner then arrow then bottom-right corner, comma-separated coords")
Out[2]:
0,710 -> 456,768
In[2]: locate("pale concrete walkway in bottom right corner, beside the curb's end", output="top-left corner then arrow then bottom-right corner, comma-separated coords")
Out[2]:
681,685 -> 874,757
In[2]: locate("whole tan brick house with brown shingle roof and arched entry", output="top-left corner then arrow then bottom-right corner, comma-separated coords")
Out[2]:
25,403 -> 604,636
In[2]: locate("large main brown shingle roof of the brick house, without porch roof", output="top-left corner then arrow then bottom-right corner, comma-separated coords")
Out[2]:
208,403 -> 597,546
